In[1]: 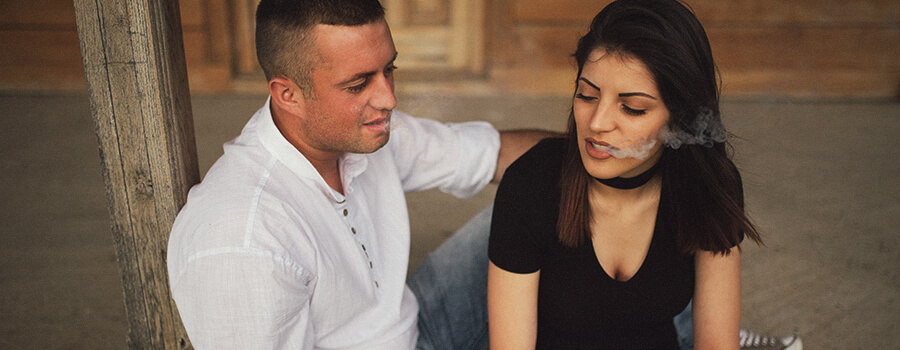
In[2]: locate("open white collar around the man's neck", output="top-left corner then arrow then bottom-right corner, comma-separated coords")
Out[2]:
257,96 -> 368,203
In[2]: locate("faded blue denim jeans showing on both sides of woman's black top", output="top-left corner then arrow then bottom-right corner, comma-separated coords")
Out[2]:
407,206 -> 694,350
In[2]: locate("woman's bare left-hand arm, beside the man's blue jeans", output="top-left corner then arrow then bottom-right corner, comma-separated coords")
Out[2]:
488,262 -> 536,350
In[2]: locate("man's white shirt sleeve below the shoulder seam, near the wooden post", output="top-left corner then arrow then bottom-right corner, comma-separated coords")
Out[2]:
172,249 -> 315,349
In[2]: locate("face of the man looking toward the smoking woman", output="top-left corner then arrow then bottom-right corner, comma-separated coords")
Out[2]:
302,20 -> 397,154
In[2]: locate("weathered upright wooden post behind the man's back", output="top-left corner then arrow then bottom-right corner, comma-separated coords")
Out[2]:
74,0 -> 200,349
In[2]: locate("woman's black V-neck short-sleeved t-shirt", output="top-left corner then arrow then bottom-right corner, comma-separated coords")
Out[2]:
489,139 -> 694,349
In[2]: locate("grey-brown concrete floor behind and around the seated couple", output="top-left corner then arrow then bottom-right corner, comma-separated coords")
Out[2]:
0,93 -> 900,349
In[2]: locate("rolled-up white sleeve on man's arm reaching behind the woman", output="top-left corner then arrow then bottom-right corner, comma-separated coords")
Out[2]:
389,111 -> 500,198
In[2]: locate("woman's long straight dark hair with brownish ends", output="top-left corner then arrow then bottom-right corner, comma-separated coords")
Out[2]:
558,0 -> 761,254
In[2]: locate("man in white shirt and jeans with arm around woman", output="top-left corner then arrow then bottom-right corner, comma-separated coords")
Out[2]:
168,0 -> 550,349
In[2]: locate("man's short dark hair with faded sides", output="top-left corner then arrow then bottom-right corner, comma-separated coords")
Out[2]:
256,0 -> 384,94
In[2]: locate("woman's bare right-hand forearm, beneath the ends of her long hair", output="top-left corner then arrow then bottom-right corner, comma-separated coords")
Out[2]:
693,247 -> 741,350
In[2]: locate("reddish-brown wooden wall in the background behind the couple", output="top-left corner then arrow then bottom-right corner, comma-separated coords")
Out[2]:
0,0 -> 900,98
